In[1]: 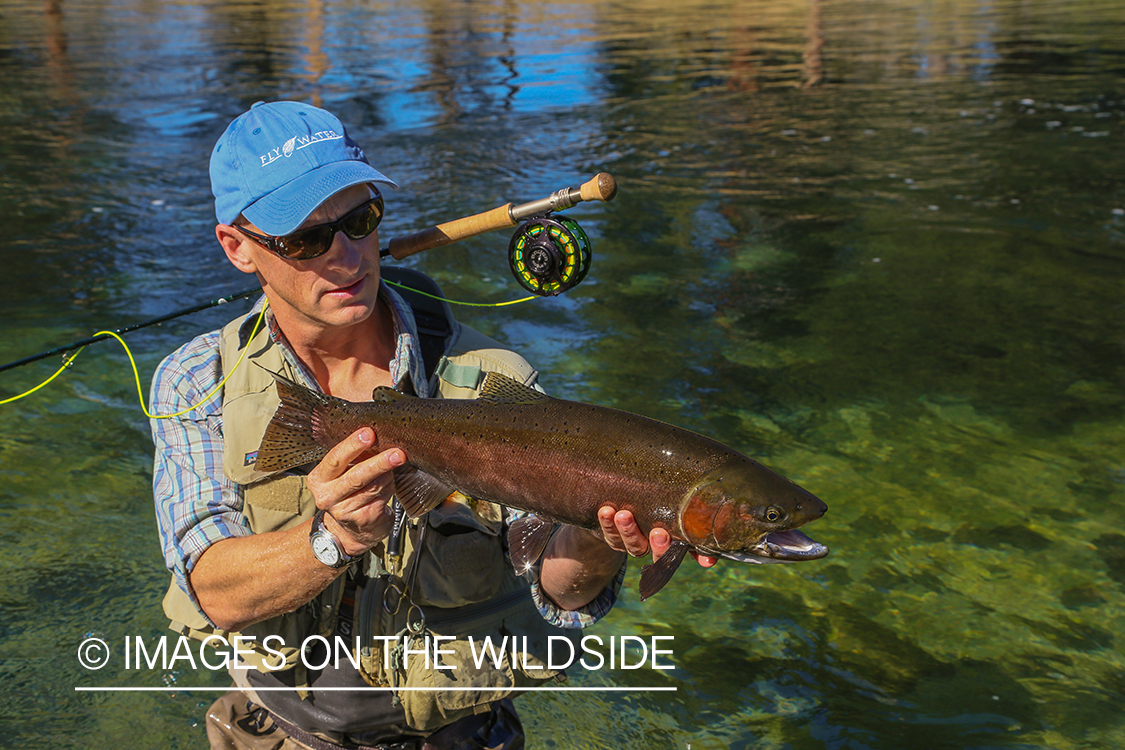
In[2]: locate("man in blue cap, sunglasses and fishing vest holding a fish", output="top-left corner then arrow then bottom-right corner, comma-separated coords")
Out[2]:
152,102 -> 711,749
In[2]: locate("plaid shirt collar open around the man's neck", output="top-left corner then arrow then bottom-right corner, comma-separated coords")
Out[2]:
239,279 -> 430,398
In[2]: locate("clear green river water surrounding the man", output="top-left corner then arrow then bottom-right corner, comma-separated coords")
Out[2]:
0,0 -> 1125,750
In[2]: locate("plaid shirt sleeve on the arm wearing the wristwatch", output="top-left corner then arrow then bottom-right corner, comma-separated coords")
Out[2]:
150,332 -> 252,617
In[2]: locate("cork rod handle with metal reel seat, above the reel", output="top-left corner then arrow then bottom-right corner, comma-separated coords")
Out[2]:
381,172 -> 618,261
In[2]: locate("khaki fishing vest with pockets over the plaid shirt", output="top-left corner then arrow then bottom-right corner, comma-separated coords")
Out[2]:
163,279 -> 574,730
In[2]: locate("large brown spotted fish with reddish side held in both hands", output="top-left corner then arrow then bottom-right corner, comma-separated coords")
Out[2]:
255,373 -> 828,599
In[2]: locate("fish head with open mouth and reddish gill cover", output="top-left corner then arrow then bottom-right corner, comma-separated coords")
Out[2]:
680,459 -> 828,562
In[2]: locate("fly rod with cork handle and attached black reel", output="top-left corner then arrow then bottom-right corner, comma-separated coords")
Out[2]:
0,172 -> 618,372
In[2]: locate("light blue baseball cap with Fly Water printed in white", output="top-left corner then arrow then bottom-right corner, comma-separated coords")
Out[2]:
210,101 -> 398,235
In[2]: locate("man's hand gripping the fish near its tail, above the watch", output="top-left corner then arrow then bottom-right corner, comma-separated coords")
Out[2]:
307,427 -> 406,555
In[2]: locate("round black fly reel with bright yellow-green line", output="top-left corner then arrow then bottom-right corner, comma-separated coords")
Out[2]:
507,214 -> 591,297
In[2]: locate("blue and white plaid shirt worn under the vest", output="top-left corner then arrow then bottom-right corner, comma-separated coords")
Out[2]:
150,278 -> 626,627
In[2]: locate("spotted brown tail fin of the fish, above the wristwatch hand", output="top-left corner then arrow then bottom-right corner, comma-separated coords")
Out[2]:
254,373 -> 369,471
